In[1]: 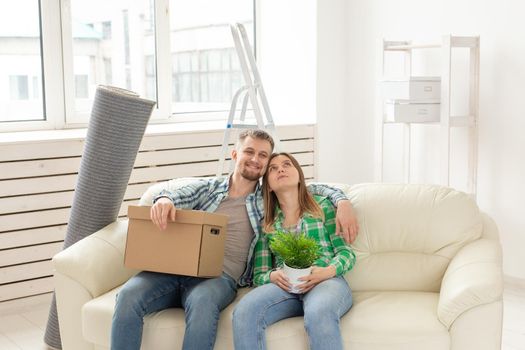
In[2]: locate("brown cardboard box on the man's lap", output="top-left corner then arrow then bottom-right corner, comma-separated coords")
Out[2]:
124,205 -> 228,277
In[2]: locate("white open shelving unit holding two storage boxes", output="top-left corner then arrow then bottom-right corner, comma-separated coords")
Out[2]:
378,35 -> 479,196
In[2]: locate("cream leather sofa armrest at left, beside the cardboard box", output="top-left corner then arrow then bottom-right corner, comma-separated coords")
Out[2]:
53,220 -> 137,298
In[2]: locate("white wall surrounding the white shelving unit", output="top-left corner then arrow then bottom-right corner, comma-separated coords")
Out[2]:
317,0 -> 525,278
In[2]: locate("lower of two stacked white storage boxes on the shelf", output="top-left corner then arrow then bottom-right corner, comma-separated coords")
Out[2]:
385,100 -> 440,123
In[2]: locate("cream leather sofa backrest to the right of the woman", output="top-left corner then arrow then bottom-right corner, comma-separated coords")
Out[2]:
342,184 -> 483,292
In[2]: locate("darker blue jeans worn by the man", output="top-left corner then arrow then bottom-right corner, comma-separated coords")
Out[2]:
111,271 -> 237,350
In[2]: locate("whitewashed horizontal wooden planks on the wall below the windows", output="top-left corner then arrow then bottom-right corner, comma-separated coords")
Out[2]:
0,125 -> 315,304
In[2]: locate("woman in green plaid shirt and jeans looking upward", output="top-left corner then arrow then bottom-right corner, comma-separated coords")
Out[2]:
233,153 -> 355,350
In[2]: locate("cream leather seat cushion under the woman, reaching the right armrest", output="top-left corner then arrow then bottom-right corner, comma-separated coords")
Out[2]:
215,288 -> 450,350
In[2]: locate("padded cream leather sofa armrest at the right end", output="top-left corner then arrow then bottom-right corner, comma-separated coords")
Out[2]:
437,238 -> 503,328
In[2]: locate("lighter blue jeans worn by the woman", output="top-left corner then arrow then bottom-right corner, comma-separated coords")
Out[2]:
233,277 -> 352,350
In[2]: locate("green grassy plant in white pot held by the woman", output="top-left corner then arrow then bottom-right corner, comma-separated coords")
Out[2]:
270,231 -> 319,293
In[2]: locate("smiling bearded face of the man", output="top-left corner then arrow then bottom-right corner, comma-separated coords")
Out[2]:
232,136 -> 272,181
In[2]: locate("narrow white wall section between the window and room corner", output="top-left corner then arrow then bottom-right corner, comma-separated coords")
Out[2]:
257,0 -> 316,125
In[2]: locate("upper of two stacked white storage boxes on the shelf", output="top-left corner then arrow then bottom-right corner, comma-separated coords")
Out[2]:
381,77 -> 441,102
